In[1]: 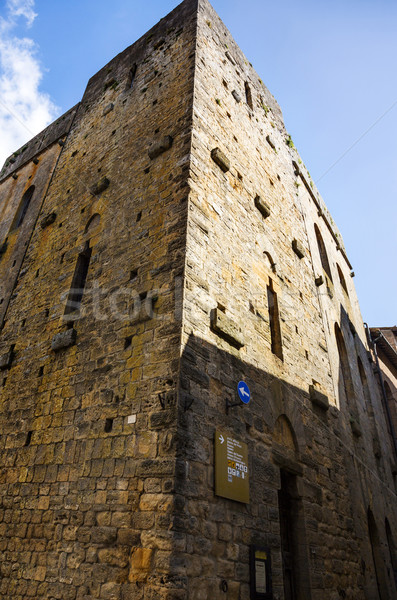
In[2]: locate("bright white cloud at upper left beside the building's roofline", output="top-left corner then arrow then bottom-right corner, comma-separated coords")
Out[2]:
0,0 -> 58,168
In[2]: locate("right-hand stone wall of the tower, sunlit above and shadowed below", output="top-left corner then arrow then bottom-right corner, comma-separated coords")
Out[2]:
180,2 -> 397,600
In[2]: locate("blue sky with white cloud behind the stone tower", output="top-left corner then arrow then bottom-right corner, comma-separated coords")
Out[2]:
0,0 -> 397,326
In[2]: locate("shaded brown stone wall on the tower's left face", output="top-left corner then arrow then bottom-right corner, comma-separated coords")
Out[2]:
0,2 -> 196,600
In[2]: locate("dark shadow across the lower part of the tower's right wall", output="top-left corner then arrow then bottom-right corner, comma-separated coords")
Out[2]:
178,325 -> 397,600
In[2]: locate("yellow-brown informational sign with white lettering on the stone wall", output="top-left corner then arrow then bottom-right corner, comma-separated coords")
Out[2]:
215,429 -> 249,504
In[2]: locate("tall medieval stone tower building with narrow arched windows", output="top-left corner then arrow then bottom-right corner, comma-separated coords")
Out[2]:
0,0 -> 397,600
